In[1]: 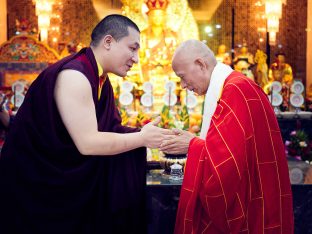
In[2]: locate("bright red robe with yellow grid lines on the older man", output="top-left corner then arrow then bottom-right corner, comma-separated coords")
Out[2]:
175,72 -> 294,234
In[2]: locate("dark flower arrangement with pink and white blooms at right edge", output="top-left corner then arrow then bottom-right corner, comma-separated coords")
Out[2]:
285,130 -> 312,163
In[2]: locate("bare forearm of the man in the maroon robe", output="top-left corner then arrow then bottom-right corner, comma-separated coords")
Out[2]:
76,132 -> 144,156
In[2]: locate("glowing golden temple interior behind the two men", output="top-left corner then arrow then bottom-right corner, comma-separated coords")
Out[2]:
0,0 -> 312,233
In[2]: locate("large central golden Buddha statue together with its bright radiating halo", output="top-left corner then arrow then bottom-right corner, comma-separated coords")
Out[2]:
121,0 -> 199,111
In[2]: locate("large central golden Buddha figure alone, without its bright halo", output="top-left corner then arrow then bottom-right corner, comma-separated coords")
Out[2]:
140,0 -> 178,81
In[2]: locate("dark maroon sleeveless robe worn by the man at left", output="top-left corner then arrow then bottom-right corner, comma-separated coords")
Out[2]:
0,48 -> 146,234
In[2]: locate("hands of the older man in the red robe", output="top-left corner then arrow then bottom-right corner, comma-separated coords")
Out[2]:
159,129 -> 195,154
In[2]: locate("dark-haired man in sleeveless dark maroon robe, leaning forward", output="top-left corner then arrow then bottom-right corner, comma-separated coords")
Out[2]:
0,15 -> 171,234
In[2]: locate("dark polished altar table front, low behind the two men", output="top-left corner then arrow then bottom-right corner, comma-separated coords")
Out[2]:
146,167 -> 312,234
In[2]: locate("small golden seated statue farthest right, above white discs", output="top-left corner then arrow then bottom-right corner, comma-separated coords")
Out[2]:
269,53 -> 293,86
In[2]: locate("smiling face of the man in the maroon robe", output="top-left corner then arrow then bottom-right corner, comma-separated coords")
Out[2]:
108,27 -> 140,77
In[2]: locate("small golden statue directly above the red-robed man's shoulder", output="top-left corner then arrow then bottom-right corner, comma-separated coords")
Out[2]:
233,44 -> 255,80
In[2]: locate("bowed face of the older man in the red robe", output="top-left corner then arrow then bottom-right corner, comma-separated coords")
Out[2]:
172,55 -> 211,95
